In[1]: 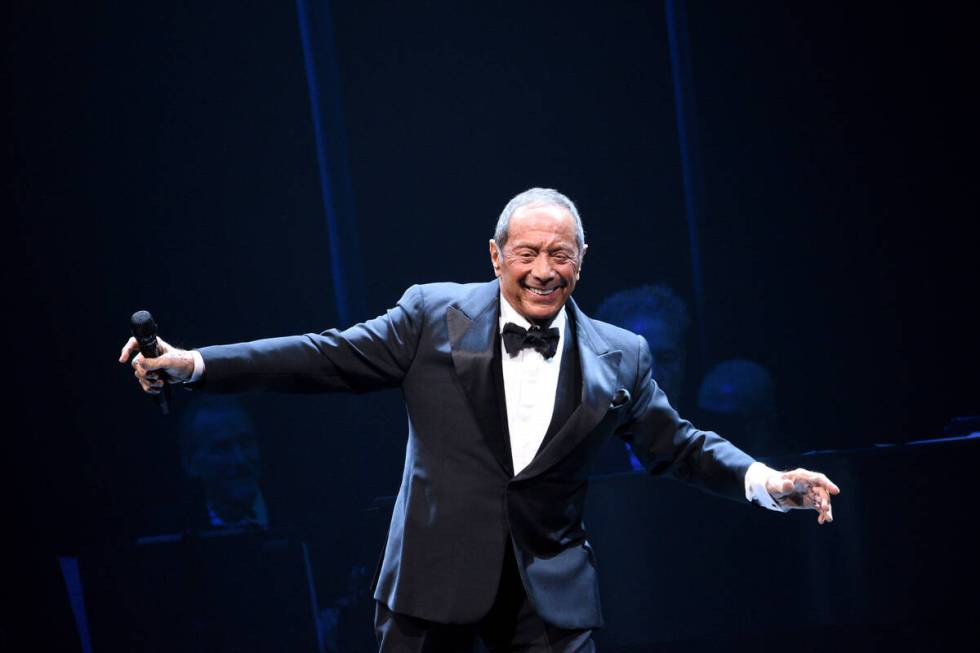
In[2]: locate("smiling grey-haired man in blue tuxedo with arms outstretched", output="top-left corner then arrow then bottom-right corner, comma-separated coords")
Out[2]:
120,188 -> 838,651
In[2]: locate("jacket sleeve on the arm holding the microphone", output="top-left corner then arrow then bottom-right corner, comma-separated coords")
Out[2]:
194,286 -> 425,393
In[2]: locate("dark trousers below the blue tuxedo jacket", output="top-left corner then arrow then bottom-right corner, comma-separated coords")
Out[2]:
374,547 -> 595,653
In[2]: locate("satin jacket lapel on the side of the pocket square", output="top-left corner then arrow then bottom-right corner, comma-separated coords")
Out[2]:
517,300 -> 623,478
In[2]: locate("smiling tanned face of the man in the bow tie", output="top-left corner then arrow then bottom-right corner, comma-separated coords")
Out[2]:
490,204 -> 588,323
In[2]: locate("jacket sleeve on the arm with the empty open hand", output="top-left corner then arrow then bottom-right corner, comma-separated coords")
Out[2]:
617,336 -> 755,501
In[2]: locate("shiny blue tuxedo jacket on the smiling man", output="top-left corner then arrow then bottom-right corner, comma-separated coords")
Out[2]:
199,281 -> 753,628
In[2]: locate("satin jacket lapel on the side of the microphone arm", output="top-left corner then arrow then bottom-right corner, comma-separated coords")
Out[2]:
446,281 -> 514,476
